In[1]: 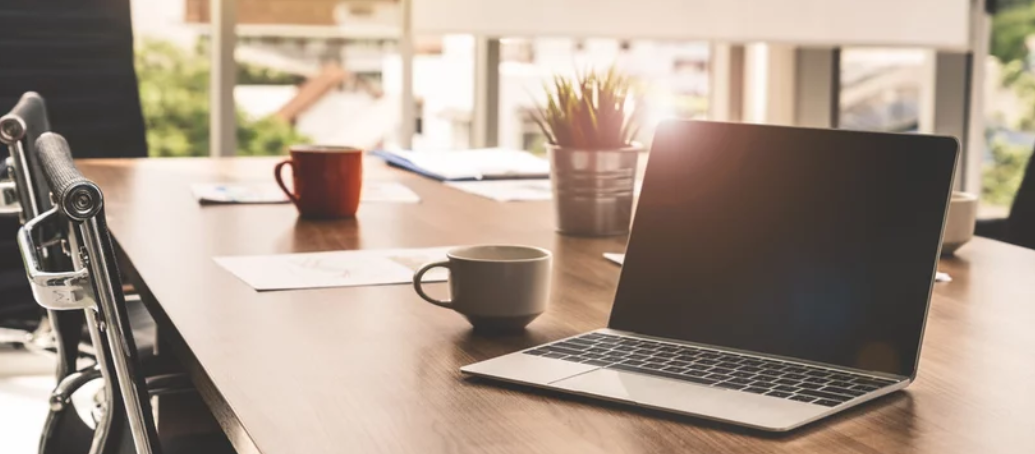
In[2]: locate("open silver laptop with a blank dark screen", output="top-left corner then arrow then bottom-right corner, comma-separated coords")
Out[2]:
461,121 -> 959,431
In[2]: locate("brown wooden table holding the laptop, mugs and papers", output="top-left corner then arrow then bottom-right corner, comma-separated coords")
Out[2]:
80,158 -> 1035,454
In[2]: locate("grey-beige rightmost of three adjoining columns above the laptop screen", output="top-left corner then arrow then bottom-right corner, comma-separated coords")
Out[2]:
794,48 -> 840,127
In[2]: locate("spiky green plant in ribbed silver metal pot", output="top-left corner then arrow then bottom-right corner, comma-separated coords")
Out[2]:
535,68 -> 643,236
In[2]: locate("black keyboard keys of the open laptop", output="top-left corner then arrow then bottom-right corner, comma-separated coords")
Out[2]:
524,333 -> 896,406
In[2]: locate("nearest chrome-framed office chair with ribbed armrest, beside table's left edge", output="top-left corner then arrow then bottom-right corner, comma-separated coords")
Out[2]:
18,132 -> 234,454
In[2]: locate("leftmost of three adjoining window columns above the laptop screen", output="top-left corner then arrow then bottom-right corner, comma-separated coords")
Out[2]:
708,42 -> 744,122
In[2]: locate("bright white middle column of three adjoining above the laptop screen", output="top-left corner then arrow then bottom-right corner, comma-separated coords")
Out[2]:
743,43 -> 796,125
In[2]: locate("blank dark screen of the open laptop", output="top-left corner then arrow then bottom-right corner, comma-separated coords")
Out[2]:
609,121 -> 958,376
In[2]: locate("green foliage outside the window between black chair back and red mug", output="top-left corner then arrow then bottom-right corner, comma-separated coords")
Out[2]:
136,39 -> 308,156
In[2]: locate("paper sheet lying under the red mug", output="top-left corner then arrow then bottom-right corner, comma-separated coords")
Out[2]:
190,181 -> 420,205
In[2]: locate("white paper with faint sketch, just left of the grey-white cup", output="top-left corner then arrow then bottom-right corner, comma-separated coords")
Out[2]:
214,247 -> 450,292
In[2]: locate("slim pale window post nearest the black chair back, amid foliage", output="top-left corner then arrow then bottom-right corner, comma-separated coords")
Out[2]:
208,0 -> 237,156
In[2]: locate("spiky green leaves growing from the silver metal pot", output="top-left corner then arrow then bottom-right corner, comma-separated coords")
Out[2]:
534,67 -> 639,150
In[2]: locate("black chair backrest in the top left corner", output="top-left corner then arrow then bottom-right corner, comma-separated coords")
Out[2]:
0,0 -> 147,157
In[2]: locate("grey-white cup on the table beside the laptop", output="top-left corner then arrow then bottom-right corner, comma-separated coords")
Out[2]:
413,246 -> 553,333
